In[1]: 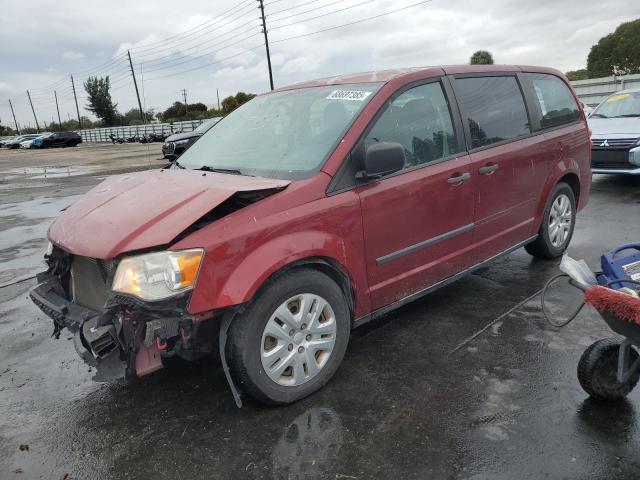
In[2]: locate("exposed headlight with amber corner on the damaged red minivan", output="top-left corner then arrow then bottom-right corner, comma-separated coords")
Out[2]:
111,248 -> 204,301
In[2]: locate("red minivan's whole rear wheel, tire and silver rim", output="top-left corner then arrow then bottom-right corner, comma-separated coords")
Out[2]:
525,182 -> 576,259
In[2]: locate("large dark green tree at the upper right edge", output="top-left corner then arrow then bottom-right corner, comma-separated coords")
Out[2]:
587,19 -> 640,78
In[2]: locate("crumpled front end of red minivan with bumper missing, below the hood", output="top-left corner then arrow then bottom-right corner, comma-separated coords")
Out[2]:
30,247 -> 217,381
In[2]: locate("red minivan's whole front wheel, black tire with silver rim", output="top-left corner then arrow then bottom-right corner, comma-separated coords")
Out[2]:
227,269 -> 351,404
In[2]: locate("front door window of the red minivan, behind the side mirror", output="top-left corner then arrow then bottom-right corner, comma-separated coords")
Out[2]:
365,82 -> 459,168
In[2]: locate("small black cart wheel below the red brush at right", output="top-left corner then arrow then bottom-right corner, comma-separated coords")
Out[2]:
578,338 -> 640,401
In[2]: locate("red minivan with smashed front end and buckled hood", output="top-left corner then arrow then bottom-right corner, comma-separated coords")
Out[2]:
31,65 -> 591,404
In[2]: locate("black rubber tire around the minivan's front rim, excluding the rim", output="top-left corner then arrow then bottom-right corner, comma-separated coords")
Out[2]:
227,268 -> 351,405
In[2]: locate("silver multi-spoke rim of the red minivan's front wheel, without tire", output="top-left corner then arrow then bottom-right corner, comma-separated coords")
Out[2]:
260,293 -> 337,387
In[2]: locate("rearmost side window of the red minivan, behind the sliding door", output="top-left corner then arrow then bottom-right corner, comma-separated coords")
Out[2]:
526,73 -> 580,128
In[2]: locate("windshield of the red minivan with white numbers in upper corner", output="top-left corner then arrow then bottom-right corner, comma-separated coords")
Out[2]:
178,83 -> 381,179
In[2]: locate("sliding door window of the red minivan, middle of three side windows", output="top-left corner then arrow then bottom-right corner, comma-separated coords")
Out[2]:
455,76 -> 531,148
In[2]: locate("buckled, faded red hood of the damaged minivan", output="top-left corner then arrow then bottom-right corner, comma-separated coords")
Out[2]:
48,169 -> 290,259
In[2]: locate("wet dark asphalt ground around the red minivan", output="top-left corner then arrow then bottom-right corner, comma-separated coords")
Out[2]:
0,153 -> 640,479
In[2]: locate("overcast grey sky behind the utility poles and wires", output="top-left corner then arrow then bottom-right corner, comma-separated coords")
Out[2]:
0,0 -> 640,130
